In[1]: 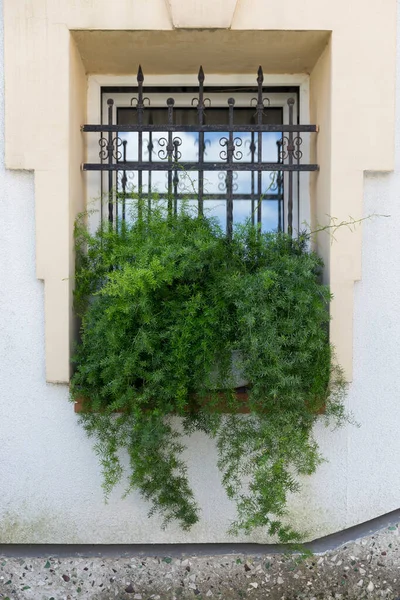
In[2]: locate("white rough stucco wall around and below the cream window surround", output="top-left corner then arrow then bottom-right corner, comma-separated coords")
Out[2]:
0,0 -> 400,543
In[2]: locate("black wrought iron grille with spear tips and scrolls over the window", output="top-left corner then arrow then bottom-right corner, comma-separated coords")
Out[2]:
82,67 -> 318,237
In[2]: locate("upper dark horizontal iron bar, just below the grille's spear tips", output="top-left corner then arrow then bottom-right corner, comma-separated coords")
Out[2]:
81,124 -> 318,133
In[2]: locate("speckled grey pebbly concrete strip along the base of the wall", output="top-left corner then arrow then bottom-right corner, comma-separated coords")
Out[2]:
0,525 -> 400,600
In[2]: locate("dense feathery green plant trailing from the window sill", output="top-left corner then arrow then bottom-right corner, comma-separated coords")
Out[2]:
71,203 -> 345,542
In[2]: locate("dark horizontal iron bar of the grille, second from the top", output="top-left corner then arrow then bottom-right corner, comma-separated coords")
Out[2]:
82,162 -> 319,173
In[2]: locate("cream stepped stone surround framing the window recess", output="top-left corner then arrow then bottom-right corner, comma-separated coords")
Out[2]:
4,0 -> 396,383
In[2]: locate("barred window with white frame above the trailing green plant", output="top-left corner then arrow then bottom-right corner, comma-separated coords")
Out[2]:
84,67 -> 317,236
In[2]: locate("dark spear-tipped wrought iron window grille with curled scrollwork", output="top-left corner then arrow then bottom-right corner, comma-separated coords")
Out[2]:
82,67 -> 318,237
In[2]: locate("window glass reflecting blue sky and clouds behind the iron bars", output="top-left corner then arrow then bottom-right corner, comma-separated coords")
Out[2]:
117,107 -> 283,231
